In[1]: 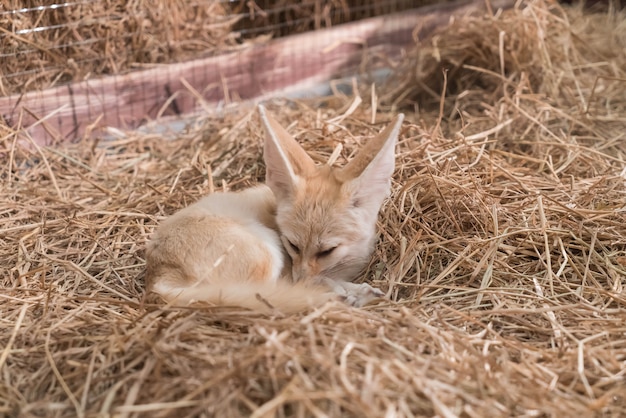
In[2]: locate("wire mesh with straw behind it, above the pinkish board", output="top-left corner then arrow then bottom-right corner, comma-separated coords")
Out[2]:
0,0 -> 448,96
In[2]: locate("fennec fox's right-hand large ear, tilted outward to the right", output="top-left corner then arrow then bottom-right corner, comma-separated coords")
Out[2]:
339,113 -> 404,213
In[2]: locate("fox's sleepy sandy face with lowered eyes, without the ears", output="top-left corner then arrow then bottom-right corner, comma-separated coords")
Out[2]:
276,166 -> 378,281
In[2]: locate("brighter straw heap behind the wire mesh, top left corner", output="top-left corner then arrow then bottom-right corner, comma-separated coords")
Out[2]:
0,0 -> 238,95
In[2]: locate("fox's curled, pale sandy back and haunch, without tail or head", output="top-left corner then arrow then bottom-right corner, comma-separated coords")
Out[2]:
146,186 -> 283,294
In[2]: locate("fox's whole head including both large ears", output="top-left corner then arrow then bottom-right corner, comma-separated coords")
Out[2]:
261,111 -> 402,281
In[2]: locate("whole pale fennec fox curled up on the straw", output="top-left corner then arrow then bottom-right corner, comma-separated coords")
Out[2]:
146,106 -> 403,313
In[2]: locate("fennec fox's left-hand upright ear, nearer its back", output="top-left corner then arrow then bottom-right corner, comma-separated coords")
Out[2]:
259,105 -> 315,199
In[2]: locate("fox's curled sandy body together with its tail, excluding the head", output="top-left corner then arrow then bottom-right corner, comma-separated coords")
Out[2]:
146,185 -> 337,313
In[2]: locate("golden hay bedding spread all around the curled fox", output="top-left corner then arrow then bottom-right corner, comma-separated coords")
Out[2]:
0,1 -> 626,417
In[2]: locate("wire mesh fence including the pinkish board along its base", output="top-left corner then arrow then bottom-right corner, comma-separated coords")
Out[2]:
0,0 -> 472,144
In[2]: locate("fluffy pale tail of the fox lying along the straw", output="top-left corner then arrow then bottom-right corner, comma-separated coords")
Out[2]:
152,282 -> 338,314
